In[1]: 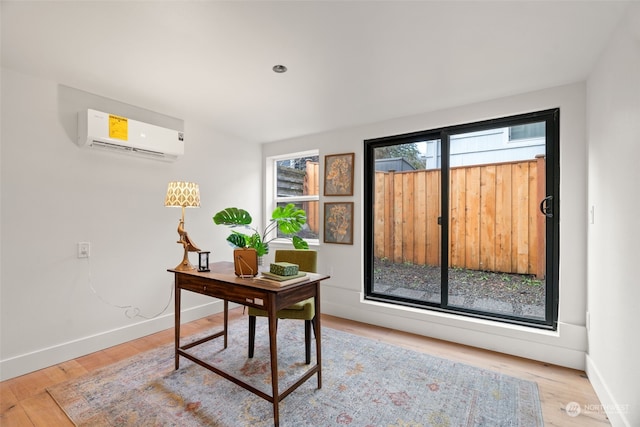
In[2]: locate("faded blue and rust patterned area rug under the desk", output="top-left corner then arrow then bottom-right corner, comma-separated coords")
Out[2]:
48,318 -> 543,427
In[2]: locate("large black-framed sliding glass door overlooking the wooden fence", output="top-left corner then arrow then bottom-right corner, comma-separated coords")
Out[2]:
364,110 -> 559,329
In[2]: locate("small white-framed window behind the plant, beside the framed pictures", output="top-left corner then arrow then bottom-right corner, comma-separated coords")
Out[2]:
267,151 -> 320,244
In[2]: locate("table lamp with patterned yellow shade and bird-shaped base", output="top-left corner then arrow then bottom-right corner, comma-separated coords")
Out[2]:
164,181 -> 200,271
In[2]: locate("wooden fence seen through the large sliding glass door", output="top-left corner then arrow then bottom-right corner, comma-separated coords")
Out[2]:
374,157 -> 545,278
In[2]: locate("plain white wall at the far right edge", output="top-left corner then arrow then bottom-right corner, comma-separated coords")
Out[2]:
578,4 -> 640,427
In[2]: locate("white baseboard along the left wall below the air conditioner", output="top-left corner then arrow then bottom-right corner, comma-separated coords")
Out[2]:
0,300 -> 223,381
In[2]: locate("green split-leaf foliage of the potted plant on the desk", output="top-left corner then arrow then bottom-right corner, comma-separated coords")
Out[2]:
213,203 -> 309,268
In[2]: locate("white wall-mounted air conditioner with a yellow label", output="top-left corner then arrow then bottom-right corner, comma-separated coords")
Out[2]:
78,109 -> 184,161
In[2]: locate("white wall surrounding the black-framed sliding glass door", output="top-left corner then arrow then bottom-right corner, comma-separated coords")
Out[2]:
263,83 -> 587,369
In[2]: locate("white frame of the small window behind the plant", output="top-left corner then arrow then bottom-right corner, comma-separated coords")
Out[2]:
265,149 -> 320,246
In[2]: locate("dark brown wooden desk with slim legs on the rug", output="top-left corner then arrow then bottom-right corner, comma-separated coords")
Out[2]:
168,262 -> 329,427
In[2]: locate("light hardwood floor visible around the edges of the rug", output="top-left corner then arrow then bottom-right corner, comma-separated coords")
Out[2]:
0,309 -> 610,427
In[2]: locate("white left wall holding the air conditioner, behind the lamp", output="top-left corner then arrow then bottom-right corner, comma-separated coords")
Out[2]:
0,69 -> 262,379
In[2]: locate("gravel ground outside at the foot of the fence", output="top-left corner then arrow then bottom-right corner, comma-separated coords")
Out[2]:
374,259 -> 545,319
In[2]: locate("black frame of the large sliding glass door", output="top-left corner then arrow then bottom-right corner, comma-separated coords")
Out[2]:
363,108 -> 560,331
